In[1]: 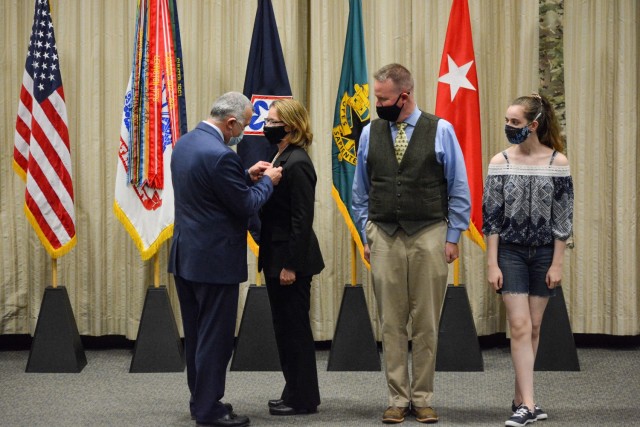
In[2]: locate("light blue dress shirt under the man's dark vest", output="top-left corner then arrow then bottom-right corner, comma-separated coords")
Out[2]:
351,107 -> 471,244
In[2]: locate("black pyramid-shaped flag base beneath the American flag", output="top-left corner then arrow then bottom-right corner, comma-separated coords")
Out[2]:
25,286 -> 87,373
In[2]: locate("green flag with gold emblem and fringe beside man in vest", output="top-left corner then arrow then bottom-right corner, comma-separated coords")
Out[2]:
331,0 -> 370,264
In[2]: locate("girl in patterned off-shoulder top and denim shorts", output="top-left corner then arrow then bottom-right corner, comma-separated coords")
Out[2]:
482,93 -> 573,427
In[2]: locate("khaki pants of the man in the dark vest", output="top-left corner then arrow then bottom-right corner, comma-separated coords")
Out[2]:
366,221 -> 448,407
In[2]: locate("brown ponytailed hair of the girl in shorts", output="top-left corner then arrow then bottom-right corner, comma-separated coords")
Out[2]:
511,92 -> 564,152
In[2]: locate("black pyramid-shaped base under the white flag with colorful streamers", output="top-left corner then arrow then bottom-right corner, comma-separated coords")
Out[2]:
129,286 -> 185,373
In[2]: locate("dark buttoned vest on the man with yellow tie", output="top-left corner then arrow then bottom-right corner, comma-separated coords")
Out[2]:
367,112 -> 449,235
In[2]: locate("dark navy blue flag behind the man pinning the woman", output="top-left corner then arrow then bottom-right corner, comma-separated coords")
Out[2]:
238,0 -> 291,256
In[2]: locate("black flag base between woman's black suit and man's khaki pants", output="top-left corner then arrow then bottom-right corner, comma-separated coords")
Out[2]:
327,285 -> 381,371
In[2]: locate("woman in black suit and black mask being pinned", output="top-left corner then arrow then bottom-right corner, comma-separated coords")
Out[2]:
258,99 -> 324,415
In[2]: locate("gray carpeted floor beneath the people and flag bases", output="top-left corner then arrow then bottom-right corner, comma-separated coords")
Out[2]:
0,347 -> 640,427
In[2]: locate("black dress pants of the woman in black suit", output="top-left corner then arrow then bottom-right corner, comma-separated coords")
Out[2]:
266,276 -> 320,409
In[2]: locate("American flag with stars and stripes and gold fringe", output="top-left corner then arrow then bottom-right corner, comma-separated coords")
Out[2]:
13,0 -> 76,258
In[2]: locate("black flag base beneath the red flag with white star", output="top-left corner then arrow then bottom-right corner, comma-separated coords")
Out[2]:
436,285 -> 484,372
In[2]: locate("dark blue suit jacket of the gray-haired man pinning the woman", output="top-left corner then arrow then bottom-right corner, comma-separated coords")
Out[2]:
168,122 -> 273,284
